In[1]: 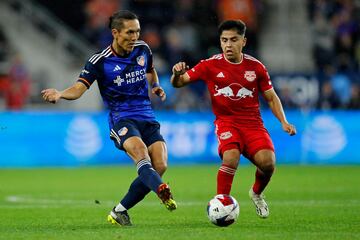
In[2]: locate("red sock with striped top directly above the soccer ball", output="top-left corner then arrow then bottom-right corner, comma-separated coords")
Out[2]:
217,164 -> 236,194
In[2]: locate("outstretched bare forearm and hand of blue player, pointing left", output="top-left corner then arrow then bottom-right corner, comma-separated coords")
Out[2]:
41,82 -> 87,103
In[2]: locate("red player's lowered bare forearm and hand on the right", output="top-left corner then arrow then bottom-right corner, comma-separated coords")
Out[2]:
263,89 -> 296,136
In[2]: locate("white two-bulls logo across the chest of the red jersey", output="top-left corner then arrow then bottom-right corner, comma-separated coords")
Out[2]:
214,83 -> 255,101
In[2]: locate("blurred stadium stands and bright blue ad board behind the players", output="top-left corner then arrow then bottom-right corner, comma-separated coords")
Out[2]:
0,0 -> 360,167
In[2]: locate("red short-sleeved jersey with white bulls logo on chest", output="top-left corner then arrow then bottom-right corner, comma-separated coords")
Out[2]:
187,54 -> 272,126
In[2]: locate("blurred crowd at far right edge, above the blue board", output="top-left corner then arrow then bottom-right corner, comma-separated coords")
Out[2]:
308,0 -> 360,109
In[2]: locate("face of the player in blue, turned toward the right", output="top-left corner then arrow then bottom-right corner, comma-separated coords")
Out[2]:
112,19 -> 140,54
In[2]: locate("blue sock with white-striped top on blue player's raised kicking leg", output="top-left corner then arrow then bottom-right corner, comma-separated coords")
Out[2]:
137,159 -> 163,193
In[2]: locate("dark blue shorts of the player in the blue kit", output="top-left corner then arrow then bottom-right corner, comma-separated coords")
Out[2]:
110,119 -> 165,151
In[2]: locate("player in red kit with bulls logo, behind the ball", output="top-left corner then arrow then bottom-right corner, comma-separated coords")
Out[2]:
171,20 -> 296,218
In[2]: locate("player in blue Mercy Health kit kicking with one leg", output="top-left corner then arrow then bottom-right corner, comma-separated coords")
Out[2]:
41,10 -> 177,226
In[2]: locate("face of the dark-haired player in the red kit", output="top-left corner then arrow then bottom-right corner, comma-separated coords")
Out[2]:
220,30 -> 246,63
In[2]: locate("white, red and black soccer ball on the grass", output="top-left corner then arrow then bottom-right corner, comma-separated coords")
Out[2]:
207,194 -> 240,227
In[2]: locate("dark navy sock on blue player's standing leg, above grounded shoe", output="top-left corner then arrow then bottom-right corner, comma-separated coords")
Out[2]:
120,177 -> 150,210
